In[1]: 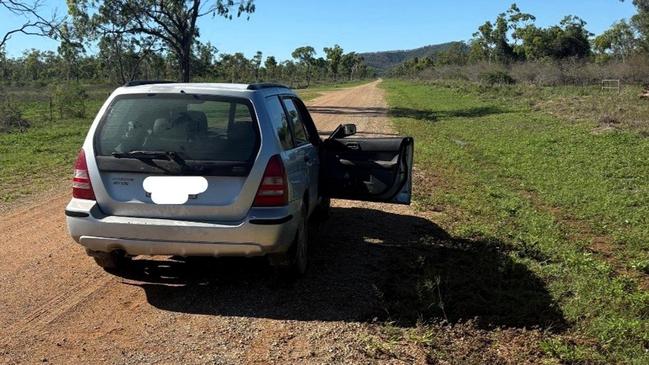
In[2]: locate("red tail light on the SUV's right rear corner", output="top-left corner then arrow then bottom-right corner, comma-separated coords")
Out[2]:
253,155 -> 288,207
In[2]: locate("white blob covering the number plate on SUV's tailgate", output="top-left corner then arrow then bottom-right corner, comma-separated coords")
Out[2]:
142,176 -> 207,204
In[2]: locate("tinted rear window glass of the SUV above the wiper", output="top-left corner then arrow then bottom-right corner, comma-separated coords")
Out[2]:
95,94 -> 259,161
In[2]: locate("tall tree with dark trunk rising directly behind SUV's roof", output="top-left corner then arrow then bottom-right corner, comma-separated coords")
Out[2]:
68,0 -> 255,82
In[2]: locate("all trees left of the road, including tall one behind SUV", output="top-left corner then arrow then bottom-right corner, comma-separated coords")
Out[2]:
0,0 -> 373,86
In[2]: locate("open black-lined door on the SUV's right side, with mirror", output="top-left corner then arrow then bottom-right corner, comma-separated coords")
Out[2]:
320,124 -> 414,204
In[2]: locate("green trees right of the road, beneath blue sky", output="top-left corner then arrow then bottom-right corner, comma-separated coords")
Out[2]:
392,0 -> 649,79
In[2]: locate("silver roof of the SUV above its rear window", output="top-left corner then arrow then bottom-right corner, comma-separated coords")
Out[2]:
118,81 -> 295,96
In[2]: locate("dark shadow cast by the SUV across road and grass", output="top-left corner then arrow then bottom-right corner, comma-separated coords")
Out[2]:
118,208 -> 565,330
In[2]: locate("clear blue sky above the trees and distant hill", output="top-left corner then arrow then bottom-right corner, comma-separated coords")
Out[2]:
0,0 -> 634,60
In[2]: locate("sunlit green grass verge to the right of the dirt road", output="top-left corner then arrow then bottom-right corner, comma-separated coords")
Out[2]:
382,80 -> 649,363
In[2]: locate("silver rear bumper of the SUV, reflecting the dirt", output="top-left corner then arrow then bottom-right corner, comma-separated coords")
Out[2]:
65,199 -> 299,256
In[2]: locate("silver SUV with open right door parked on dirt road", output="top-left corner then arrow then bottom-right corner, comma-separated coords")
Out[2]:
65,81 -> 413,274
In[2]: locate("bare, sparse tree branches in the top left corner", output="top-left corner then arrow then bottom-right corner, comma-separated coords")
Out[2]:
0,0 -> 60,49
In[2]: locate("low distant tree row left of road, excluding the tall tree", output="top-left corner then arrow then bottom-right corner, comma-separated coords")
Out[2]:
0,39 -> 374,87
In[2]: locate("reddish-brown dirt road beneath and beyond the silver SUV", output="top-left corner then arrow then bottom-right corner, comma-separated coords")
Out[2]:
0,82 -> 458,364
